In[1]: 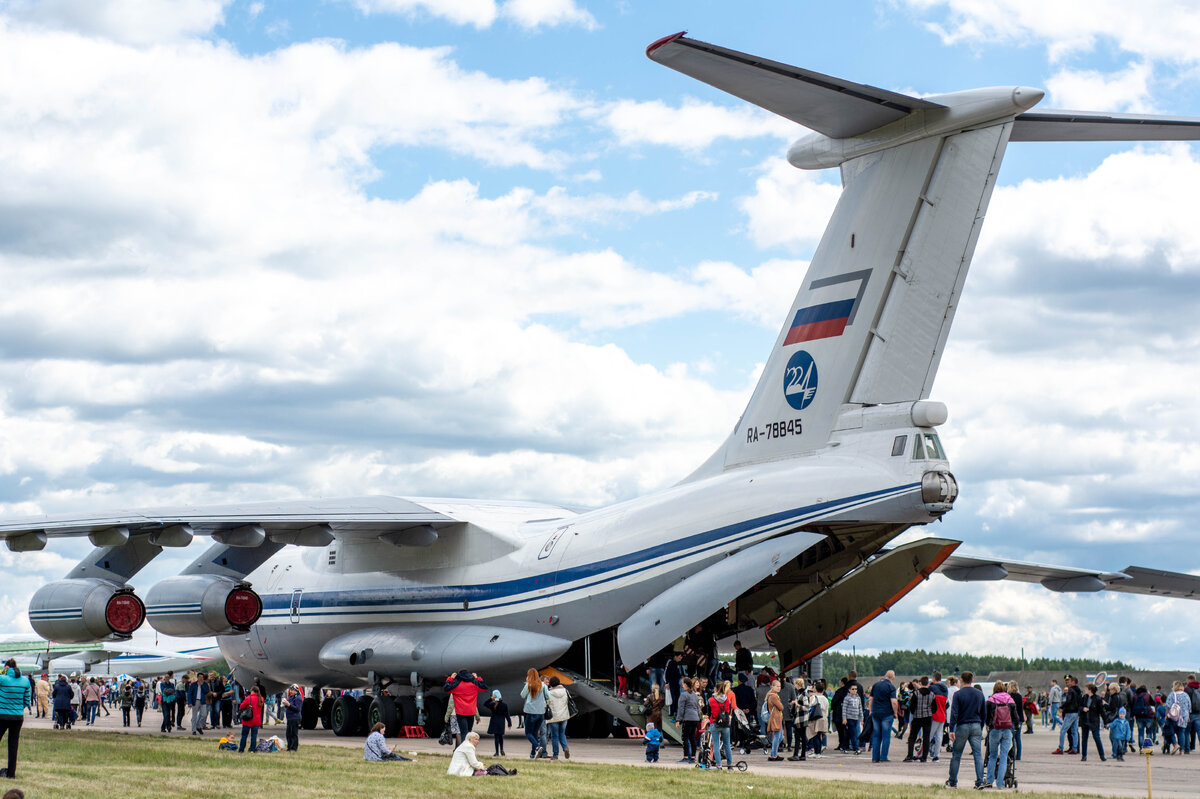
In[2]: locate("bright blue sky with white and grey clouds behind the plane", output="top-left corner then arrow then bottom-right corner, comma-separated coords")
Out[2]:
0,0 -> 1200,668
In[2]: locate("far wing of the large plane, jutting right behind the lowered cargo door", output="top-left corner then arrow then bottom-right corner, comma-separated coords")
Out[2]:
938,554 -> 1200,600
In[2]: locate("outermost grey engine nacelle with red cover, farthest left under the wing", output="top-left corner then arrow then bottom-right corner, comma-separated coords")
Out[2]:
29,577 -> 146,643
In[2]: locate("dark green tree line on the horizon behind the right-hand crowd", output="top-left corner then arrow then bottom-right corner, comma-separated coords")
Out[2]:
822,649 -> 1135,679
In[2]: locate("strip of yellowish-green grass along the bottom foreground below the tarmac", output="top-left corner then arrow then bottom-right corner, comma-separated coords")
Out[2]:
9,729 -> 1108,799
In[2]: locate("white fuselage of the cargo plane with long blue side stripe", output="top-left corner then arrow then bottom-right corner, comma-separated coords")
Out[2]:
218,428 -> 947,686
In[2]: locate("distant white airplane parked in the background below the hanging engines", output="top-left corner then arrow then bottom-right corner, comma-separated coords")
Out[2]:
0,636 -> 221,677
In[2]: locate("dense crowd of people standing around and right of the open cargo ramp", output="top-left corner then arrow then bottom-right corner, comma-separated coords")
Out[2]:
618,643 -> 1200,789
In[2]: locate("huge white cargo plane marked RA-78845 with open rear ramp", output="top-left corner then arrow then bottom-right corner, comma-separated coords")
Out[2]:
0,34 -> 1200,734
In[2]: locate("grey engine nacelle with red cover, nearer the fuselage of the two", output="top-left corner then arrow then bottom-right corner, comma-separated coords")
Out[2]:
146,575 -> 263,638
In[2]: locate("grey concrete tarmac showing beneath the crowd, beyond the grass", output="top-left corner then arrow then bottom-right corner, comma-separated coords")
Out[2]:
25,709 -> 1200,799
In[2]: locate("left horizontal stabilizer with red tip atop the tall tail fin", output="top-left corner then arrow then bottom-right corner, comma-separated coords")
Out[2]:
646,34 -> 941,139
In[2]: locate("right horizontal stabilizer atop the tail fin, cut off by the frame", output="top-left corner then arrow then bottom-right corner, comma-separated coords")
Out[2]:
1009,110 -> 1200,142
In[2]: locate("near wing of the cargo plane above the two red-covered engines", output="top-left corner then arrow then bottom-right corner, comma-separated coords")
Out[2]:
0,497 -> 458,551
